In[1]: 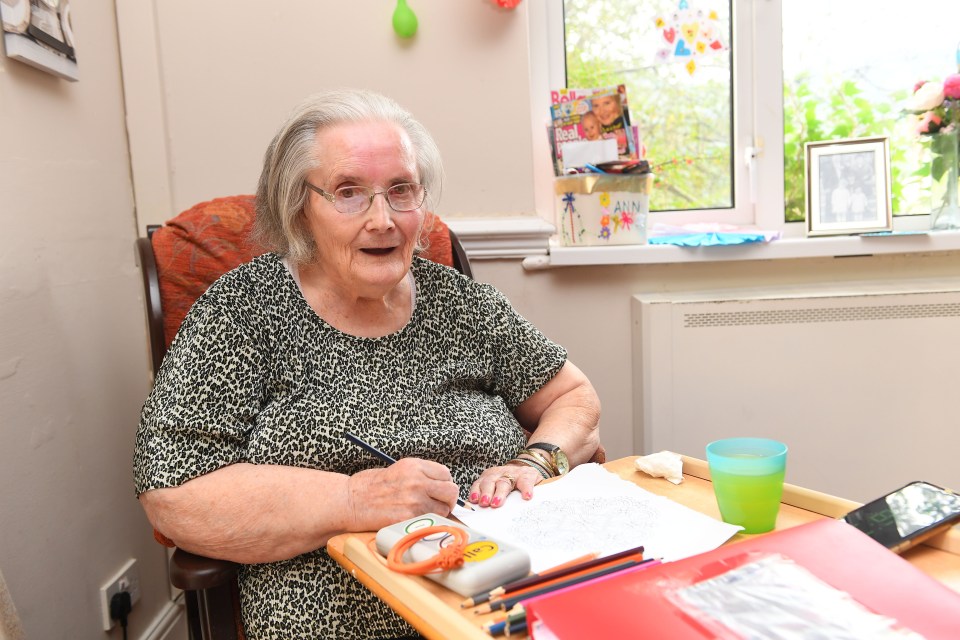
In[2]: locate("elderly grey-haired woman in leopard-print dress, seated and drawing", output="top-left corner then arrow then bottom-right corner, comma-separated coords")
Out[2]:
134,91 -> 600,639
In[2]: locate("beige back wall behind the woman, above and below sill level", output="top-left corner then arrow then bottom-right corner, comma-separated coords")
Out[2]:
121,0 -> 960,468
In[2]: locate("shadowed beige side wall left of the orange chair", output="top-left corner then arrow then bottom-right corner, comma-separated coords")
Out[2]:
0,2 -> 169,640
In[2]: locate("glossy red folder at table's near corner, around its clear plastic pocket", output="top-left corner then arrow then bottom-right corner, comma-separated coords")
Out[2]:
525,518 -> 960,640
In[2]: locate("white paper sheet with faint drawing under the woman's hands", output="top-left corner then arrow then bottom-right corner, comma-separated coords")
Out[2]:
453,463 -> 740,572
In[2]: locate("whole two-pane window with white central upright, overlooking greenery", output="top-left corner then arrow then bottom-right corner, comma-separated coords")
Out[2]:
548,0 -> 960,237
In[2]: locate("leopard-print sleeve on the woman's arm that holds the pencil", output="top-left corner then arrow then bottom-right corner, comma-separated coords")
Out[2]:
134,290 -> 265,495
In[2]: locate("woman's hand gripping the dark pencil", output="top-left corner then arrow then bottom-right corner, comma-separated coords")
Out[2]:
347,458 -> 460,531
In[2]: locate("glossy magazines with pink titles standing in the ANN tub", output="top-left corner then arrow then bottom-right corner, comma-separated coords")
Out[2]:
550,84 -> 639,175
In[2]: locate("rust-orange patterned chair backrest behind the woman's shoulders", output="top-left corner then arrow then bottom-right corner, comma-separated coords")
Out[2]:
152,196 -> 453,347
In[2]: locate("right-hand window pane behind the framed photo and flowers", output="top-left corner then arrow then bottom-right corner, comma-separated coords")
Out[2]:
782,0 -> 960,221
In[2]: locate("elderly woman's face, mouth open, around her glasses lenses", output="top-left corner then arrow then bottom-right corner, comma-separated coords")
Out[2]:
303,121 -> 423,298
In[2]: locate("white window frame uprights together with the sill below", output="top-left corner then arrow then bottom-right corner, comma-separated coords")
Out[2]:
525,0 -> 960,266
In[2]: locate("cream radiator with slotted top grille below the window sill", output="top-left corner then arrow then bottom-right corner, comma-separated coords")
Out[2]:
632,283 -> 960,501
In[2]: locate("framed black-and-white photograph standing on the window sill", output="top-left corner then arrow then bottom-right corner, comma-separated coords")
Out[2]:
804,136 -> 893,236
